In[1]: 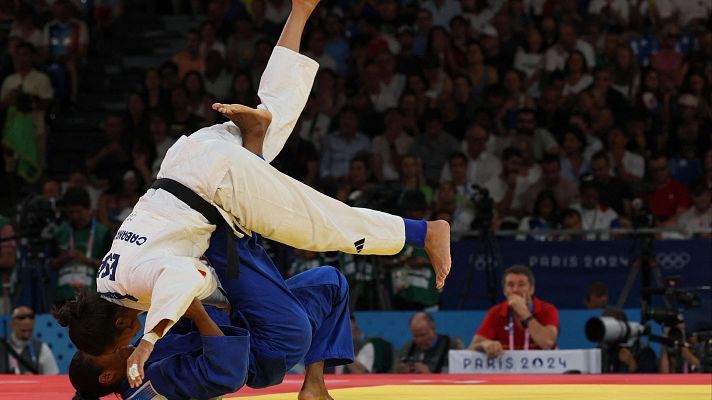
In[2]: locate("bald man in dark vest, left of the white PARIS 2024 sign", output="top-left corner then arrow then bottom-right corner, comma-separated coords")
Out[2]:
398,312 -> 464,374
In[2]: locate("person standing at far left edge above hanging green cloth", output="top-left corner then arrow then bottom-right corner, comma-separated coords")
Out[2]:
0,42 -> 54,176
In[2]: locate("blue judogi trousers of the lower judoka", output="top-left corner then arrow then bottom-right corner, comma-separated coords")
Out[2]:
205,225 -> 353,387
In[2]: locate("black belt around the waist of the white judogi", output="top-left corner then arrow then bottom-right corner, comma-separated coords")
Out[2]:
151,178 -> 240,279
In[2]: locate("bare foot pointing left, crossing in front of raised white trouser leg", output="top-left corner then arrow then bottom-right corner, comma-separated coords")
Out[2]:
213,103 -> 272,155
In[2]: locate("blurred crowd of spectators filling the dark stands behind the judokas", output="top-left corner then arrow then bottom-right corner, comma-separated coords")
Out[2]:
0,0 -> 712,316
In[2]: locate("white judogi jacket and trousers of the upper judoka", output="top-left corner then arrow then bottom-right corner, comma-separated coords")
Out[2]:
97,47 -> 405,340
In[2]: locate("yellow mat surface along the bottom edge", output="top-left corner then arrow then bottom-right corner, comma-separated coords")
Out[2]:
232,385 -> 712,400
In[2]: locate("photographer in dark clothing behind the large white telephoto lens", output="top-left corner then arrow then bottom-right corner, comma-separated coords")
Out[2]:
602,308 -> 658,374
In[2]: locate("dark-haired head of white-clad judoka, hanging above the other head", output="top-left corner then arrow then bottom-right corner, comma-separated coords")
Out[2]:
52,290 -> 141,356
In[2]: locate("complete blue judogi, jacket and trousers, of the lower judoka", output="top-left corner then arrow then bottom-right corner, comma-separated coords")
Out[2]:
118,225 -> 353,400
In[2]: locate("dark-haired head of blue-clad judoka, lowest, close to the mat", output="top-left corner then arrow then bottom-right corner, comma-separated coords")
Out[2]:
69,346 -> 134,400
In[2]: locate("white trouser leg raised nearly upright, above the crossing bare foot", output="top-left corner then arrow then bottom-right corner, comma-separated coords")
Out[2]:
257,46 -> 319,162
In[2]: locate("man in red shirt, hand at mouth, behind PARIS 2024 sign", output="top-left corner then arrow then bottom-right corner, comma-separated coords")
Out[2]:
468,265 -> 559,357
